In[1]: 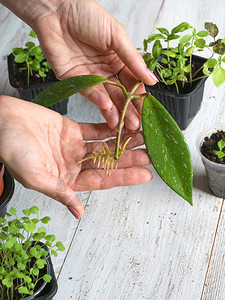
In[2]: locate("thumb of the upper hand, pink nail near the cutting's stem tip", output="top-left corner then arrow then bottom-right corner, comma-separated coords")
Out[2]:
111,21 -> 158,85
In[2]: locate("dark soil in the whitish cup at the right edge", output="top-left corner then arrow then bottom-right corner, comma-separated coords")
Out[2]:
200,130 -> 225,164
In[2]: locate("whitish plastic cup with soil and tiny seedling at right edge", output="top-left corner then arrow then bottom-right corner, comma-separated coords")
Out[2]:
197,123 -> 225,198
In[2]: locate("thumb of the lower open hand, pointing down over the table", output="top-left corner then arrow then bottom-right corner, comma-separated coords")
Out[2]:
32,175 -> 84,219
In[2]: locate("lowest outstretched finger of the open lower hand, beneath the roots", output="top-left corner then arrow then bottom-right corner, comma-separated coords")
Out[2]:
74,167 -> 152,191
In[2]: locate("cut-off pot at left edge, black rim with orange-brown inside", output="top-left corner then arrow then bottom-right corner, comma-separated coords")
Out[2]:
0,162 -> 15,217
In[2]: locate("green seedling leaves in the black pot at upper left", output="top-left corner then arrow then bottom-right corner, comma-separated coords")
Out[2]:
12,30 -> 51,85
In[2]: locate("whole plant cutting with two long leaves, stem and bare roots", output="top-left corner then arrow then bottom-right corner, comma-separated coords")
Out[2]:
33,75 -> 193,204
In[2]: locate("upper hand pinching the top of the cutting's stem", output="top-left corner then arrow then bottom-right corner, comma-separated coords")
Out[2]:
0,0 -> 157,130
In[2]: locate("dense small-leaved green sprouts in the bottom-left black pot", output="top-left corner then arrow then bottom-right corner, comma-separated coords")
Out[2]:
0,206 -> 65,300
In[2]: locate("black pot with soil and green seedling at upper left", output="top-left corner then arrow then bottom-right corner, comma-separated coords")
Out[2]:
8,30 -> 68,115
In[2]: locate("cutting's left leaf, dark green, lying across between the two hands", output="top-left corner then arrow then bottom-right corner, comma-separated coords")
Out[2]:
33,75 -> 108,107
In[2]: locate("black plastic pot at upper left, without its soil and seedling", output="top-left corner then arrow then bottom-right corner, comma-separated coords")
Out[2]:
8,53 -> 69,115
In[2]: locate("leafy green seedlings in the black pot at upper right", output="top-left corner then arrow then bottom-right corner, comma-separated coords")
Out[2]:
141,22 -> 225,93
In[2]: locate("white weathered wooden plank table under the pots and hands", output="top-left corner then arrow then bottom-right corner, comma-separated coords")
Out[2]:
0,0 -> 225,300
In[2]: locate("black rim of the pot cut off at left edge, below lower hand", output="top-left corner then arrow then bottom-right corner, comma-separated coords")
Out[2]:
0,164 -> 15,218
